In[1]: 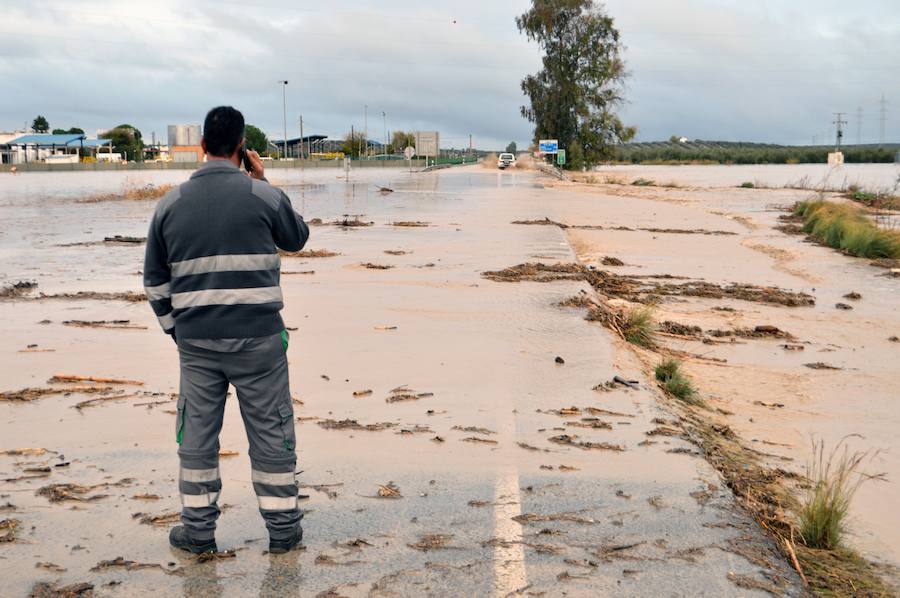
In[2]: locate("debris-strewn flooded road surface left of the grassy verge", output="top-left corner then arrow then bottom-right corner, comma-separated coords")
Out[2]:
0,167 -> 799,596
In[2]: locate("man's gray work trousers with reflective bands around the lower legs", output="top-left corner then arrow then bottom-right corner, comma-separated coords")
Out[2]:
175,332 -> 303,540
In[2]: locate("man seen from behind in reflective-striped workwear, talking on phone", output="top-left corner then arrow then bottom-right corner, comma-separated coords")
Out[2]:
144,106 -> 309,553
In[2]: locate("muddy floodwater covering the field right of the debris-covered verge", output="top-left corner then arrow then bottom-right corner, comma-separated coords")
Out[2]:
540,165 -> 900,580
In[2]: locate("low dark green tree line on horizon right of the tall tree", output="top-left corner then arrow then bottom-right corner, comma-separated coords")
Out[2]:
613,139 -> 900,164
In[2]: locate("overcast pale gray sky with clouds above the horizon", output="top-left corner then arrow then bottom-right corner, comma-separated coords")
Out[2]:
0,0 -> 900,148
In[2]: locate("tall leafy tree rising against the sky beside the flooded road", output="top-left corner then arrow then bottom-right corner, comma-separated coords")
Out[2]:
516,0 -> 636,168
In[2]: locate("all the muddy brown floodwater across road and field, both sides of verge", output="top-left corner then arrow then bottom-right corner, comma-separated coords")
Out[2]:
0,167 -> 900,596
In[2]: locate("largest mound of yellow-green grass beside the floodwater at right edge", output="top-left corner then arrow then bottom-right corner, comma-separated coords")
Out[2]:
794,200 -> 900,258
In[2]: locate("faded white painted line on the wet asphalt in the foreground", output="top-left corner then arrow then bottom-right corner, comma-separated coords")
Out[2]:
494,469 -> 528,597
